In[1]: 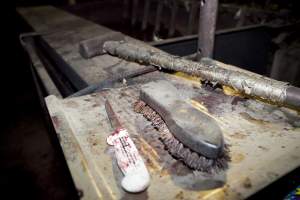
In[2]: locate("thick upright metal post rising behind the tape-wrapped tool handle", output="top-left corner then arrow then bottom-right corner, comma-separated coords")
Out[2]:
197,0 -> 218,60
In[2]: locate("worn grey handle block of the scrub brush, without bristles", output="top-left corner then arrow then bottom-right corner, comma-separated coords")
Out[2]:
140,80 -> 224,159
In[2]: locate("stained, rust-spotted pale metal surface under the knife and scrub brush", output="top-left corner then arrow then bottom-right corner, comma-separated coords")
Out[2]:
46,72 -> 300,199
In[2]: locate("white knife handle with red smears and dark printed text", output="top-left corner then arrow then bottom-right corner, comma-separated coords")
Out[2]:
107,129 -> 150,192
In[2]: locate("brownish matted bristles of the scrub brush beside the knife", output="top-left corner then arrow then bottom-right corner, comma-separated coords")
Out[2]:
134,100 -> 230,173
